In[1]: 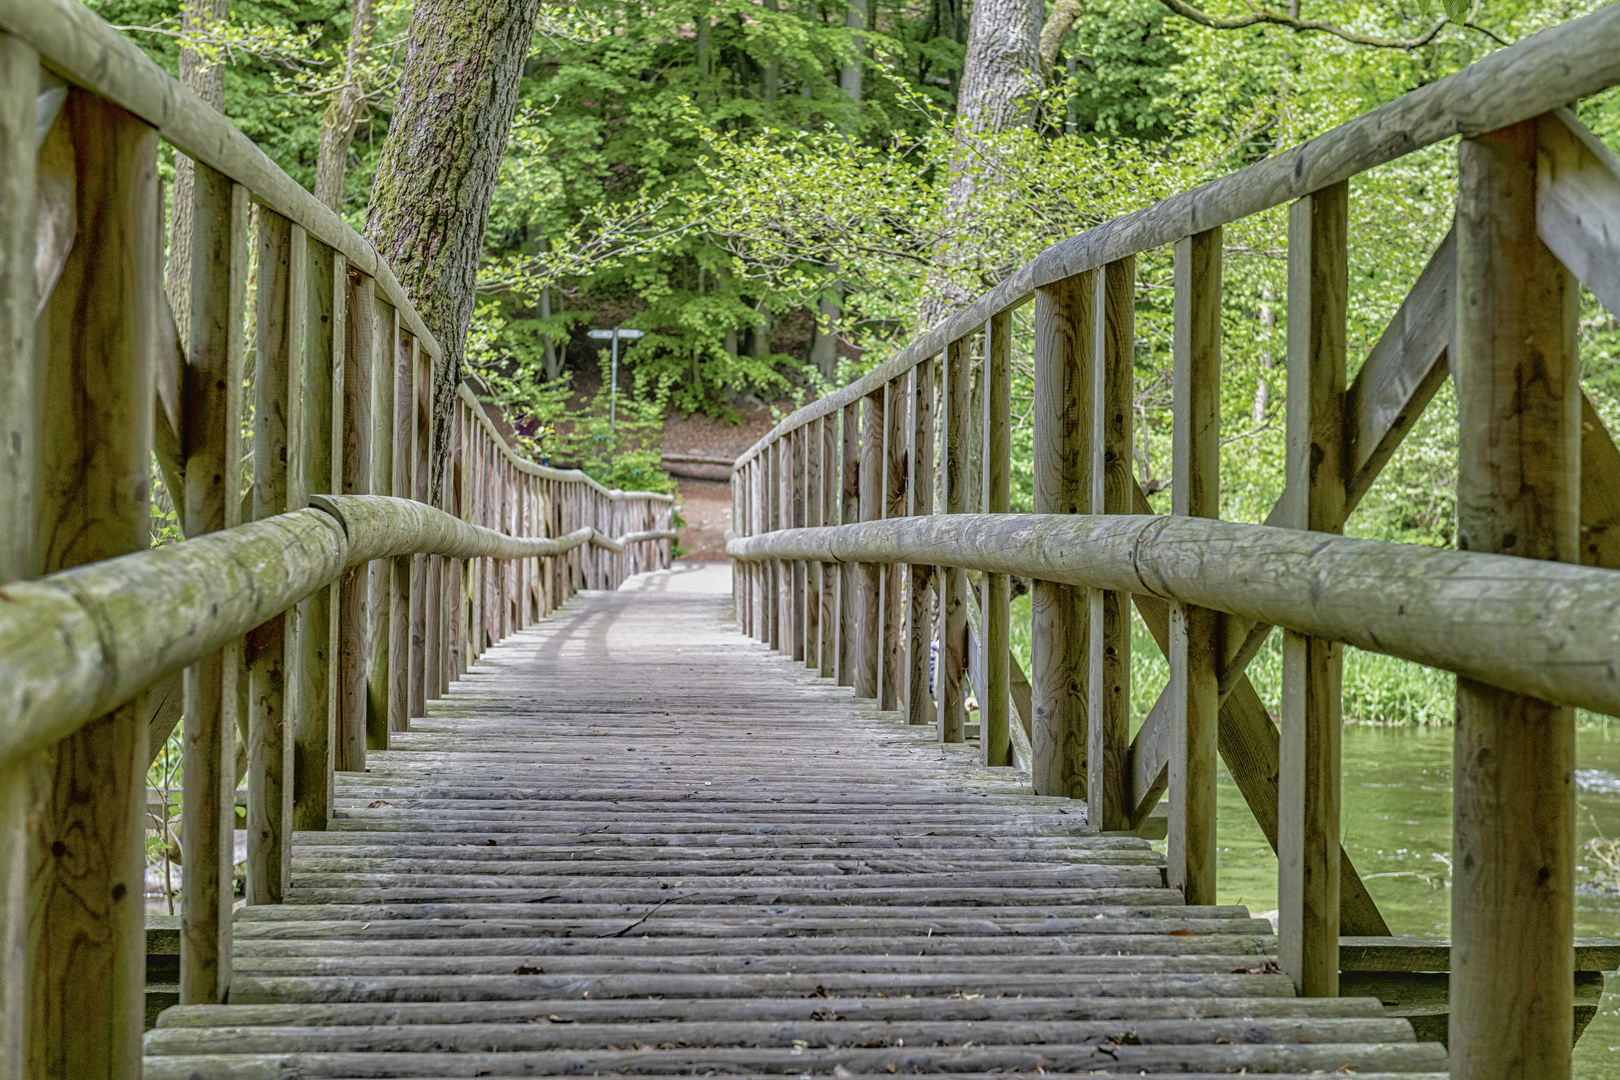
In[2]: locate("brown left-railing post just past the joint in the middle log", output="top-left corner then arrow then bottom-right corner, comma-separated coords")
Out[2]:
332,270 -> 377,772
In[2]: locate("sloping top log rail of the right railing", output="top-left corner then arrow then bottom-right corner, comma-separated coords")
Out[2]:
735,0 -> 1620,468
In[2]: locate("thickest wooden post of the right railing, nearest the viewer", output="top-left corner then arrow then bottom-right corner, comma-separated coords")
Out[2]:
1450,120 -> 1581,1080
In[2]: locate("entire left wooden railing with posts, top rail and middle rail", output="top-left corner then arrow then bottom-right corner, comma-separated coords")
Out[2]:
0,0 -> 674,1080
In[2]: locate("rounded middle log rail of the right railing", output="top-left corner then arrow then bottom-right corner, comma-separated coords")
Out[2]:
726,513 -> 1620,714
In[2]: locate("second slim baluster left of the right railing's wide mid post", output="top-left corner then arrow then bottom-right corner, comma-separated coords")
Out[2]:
933,338 -> 972,743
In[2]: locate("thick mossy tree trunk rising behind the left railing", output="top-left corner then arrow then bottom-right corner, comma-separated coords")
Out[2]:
366,0 -> 539,495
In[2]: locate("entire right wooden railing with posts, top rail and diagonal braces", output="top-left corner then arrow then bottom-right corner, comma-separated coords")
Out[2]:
727,8 -> 1620,1077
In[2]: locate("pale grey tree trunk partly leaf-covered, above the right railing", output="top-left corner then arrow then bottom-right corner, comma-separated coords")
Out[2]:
919,0 -> 1045,329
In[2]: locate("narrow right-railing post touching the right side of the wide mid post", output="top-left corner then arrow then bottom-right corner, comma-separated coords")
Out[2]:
1085,256 -> 1136,831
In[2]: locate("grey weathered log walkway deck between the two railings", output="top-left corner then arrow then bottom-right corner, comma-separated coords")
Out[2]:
146,567 -> 1445,1080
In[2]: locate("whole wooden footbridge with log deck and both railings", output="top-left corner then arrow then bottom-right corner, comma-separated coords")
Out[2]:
0,0 -> 1620,1080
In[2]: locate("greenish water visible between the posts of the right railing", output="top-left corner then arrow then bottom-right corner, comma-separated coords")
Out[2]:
1217,722 -> 1620,1080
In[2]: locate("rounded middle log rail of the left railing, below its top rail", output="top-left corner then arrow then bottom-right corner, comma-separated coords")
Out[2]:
0,495 -> 674,763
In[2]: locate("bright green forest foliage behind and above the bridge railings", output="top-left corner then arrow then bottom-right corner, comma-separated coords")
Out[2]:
101,0 -> 1620,527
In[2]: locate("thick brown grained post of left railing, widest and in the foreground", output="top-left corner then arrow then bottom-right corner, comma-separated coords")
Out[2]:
29,89 -> 162,1080
